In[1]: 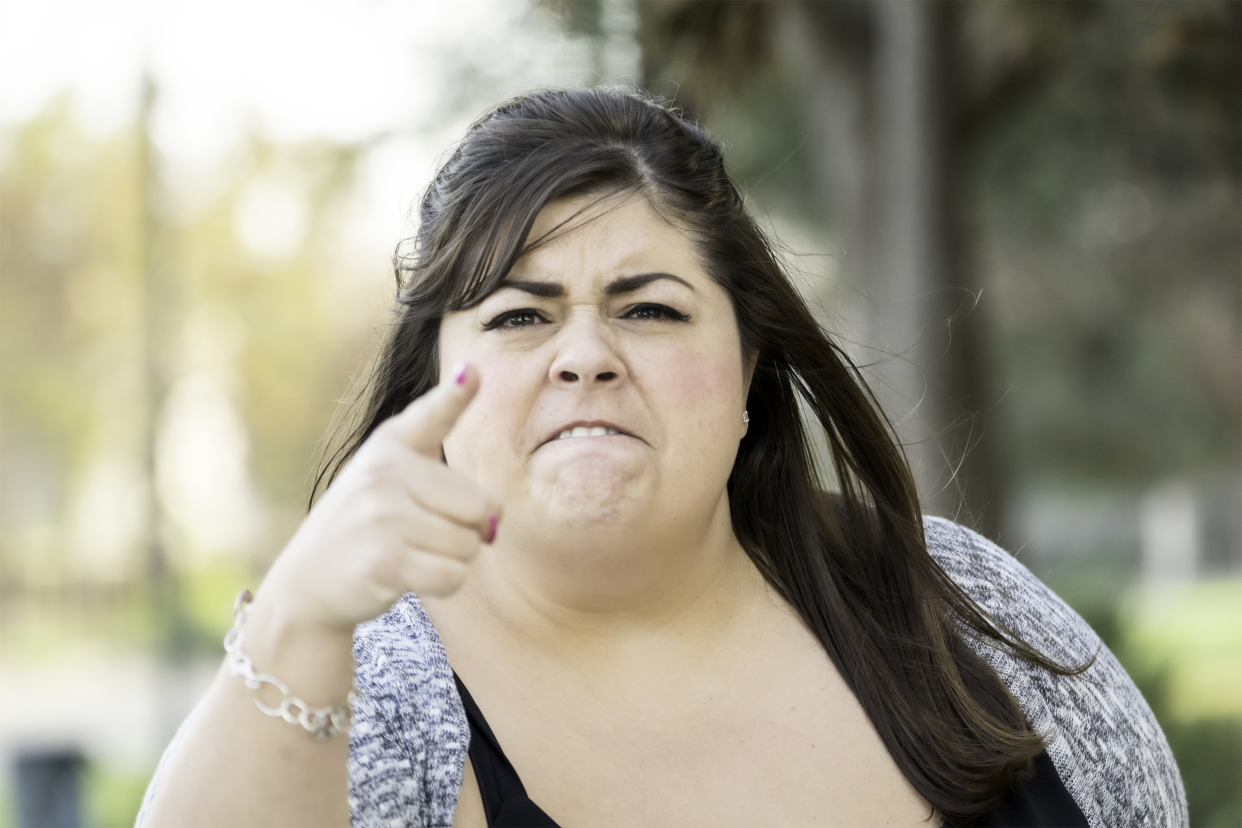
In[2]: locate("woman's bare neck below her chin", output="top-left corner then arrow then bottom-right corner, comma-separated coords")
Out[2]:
461,497 -> 763,654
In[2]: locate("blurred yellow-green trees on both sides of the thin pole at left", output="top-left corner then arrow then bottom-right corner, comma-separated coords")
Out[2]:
0,99 -> 372,628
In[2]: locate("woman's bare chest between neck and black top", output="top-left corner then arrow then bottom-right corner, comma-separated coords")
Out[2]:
442,625 -> 930,828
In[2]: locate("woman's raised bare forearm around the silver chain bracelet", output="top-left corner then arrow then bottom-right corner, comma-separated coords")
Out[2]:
143,600 -> 354,828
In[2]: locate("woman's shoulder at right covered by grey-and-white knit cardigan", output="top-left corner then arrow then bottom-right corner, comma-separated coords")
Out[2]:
923,518 -> 1189,828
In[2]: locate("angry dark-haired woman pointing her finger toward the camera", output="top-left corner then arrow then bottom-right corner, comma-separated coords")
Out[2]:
139,89 -> 1186,828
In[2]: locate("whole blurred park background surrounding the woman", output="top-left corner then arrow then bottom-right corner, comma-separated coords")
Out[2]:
0,0 -> 1242,828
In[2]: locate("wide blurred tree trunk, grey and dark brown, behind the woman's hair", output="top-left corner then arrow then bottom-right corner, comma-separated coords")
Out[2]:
777,0 -> 1002,536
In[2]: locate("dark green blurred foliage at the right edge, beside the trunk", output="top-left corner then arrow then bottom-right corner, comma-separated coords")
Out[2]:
976,0 -> 1242,485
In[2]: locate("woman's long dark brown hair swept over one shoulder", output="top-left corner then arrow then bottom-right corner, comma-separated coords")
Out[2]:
312,88 -> 1071,826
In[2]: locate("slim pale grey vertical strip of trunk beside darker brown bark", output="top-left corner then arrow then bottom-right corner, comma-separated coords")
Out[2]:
863,0 -> 954,514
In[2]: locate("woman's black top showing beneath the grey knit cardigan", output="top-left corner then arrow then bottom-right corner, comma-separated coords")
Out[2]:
453,673 -> 1089,828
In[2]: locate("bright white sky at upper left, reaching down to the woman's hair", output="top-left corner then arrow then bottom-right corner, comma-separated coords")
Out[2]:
0,0 -> 625,250
